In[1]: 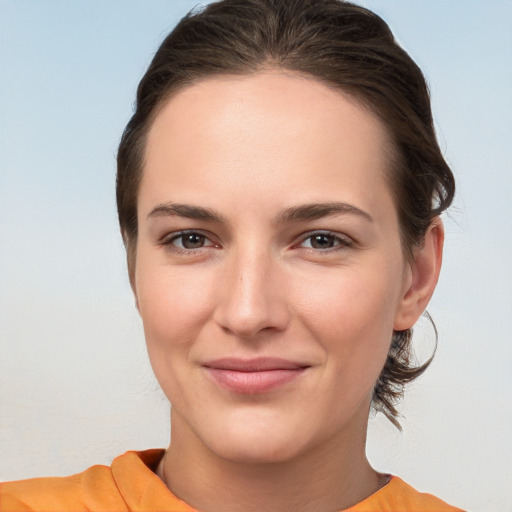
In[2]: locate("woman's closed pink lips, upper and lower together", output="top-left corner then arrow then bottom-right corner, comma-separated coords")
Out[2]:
203,358 -> 310,395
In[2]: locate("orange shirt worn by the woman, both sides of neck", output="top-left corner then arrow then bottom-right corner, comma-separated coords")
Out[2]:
0,450 -> 462,512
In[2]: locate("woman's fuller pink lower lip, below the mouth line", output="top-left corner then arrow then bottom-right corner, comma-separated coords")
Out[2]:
206,368 -> 306,395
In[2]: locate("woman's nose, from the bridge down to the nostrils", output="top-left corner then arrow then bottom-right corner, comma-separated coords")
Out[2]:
214,250 -> 290,339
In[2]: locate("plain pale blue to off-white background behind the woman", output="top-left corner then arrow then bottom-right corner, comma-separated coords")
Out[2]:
0,0 -> 512,512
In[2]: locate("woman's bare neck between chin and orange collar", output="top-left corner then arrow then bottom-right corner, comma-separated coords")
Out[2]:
159,413 -> 386,512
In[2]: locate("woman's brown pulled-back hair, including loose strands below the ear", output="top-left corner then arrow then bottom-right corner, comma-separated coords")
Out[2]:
117,0 -> 455,427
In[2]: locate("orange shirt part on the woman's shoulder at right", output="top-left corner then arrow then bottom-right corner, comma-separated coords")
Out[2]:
344,476 -> 464,512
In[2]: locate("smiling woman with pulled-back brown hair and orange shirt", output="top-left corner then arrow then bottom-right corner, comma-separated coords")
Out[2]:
0,0 -> 464,512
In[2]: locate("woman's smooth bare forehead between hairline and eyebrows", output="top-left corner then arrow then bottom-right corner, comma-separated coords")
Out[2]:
140,71 -> 391,214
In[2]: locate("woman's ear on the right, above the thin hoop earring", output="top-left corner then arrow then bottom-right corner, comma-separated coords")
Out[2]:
393,217 -> 444,331
